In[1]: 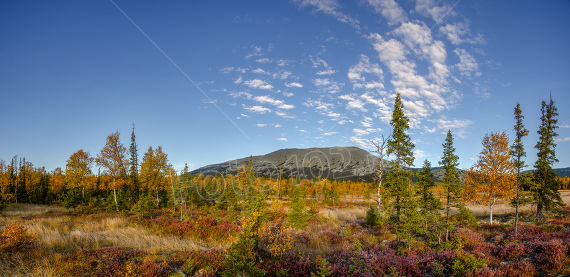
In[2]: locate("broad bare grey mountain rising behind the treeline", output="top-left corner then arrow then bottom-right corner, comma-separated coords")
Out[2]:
191,147 -> 570,182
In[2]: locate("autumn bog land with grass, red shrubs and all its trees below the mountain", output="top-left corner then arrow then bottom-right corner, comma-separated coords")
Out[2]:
0,95 -> 570,276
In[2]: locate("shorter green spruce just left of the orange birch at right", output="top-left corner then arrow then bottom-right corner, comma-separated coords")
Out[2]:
439,130 -> 462,242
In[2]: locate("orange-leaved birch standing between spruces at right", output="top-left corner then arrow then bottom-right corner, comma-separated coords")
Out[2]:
464,131 -> 517,224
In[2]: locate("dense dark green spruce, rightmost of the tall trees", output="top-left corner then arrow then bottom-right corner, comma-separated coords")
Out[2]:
530,96 -> 564,221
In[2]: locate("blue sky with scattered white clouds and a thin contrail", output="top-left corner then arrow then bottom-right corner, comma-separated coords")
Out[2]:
0,0 -> 570,170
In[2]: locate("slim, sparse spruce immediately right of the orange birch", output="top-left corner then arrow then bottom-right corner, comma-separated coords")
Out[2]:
511,103 -> 528,237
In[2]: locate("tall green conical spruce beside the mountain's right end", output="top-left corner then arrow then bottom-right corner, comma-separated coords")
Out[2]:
386,93 -> 414,222
